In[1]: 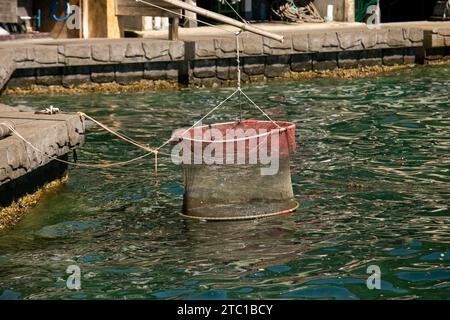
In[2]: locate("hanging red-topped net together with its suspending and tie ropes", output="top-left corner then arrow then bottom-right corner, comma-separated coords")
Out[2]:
7,0 -> 298,221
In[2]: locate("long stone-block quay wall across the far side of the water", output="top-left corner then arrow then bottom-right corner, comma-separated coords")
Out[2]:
0,24 -> 450,88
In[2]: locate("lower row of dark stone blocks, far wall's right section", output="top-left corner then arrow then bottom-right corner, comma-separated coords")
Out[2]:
190,48 -> 417,86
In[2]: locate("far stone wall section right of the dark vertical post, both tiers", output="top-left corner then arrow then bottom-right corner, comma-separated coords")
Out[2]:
189,28 -> 423,85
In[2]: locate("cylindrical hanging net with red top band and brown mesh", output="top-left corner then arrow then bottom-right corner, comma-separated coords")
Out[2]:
174,120 -> 297,220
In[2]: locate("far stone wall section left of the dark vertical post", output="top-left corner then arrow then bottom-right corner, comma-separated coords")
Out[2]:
8,39 -> 185,88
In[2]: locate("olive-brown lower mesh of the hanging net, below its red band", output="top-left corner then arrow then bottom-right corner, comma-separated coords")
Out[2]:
183,156 -> 297,220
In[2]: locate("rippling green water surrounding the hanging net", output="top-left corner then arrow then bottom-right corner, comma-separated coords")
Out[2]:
0,66 -> 450,299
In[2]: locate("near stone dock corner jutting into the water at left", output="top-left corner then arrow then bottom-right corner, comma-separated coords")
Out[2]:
0,104 -> 84,207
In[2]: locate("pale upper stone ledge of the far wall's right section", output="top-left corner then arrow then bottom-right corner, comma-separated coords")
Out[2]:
194,27 -> 423,60
